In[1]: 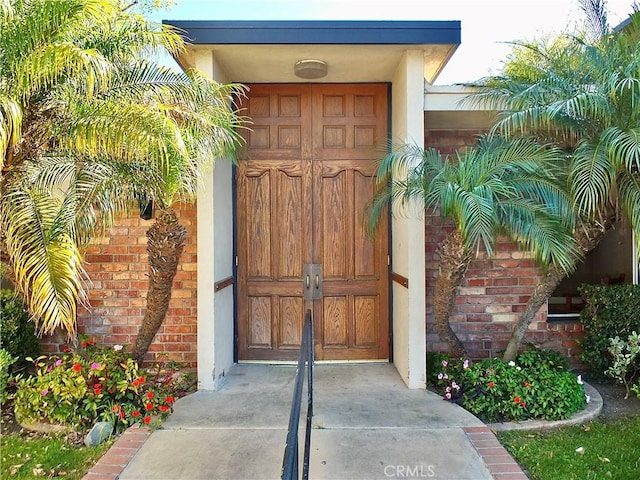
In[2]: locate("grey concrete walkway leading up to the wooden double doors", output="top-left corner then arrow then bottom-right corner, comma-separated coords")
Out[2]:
85,364 -> 527,480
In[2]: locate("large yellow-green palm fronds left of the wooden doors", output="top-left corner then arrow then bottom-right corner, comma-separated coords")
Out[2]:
0,0 -> 242,348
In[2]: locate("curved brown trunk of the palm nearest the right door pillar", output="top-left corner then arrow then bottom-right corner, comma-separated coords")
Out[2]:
433,230 -> 471,357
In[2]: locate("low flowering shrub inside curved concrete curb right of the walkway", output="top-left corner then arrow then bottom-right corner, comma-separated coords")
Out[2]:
430,350 -> 588,422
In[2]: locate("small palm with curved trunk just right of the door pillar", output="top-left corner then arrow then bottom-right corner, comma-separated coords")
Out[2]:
370,137 -> 575,357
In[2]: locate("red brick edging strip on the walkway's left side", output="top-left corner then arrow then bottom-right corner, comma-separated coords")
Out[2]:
82,426 -> 151,480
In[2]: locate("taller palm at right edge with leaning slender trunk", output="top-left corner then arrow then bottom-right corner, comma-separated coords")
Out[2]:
464,0 -> 640,360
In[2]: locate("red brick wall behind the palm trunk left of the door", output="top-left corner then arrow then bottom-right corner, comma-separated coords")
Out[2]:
42,205 -> 197,366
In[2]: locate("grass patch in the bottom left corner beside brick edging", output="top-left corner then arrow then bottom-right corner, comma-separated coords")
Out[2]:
0,433 -> 113,480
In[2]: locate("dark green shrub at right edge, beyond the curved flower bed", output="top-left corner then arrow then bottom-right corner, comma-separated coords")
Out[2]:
578,284 -> 640,379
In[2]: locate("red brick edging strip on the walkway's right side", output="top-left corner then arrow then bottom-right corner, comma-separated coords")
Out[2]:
463,426 -> 527,480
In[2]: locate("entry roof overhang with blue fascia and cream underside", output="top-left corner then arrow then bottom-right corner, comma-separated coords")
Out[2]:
163,20 -> 460,83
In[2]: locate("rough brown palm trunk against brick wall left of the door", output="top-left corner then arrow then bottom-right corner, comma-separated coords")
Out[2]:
132,210 -> 187,365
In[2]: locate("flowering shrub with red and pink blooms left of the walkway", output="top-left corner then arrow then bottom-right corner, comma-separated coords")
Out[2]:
15,342 -> 175,431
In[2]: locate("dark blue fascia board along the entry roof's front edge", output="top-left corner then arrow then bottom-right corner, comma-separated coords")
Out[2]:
162,20 -> 460,45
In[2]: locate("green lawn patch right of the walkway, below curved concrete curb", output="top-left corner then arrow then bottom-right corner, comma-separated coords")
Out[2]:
498,415 -> 640,480
